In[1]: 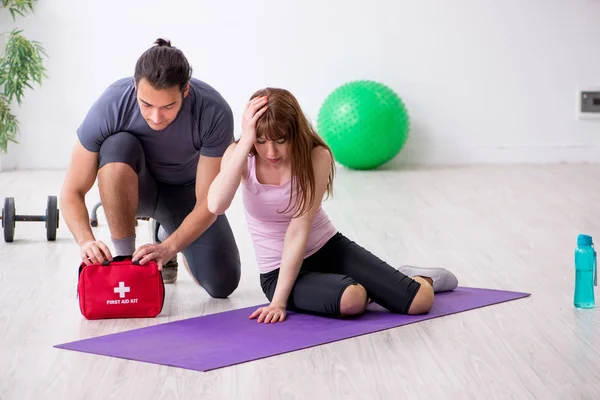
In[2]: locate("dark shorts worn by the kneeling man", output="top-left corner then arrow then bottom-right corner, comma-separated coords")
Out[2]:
99,132 -> 241,298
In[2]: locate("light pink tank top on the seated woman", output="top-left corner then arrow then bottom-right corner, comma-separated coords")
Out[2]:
243,156 -> 337,274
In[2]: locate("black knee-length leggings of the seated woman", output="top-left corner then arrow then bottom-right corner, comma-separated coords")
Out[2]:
260,232 -> 421,317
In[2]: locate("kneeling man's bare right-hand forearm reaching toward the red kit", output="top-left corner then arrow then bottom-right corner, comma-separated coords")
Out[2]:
163,203 -> 217,253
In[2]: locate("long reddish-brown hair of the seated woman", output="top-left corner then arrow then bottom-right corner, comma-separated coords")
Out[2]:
250,88 -> 335,216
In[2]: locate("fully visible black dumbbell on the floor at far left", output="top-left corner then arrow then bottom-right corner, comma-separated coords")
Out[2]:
2,196 -> 60,242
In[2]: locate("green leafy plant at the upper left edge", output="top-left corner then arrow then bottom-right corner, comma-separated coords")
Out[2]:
0,0 -> 47,170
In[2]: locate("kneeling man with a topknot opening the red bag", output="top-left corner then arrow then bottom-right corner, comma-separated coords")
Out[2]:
61,39 -> 240,298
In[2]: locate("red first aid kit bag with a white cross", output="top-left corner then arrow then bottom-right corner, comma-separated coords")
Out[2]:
77,256 -> 165,319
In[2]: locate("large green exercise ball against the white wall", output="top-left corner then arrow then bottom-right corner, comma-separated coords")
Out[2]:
317,80 -> 410,170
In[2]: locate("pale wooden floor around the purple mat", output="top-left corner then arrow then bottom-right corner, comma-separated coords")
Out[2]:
0,165 -> 600,400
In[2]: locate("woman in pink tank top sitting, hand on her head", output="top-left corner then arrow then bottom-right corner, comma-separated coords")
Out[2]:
208,88 -> 458,323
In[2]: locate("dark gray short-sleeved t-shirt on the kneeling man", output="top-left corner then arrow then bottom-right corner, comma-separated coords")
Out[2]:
77,77 -> 233,185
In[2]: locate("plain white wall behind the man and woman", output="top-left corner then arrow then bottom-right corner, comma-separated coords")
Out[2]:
0,0 -> 600,169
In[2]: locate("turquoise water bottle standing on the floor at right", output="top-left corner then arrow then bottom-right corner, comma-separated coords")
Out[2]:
574,234 -> 598,308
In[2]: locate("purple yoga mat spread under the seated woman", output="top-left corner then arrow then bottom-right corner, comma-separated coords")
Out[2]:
54,287 -> 529,371
